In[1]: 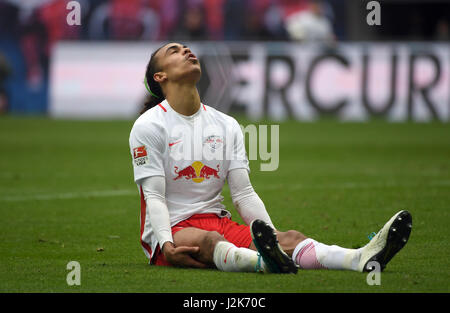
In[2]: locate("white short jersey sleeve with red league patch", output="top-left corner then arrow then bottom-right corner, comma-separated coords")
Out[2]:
129,123 -> 166,183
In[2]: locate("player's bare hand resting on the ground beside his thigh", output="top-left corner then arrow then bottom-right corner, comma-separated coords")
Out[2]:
163,242 -> 207,268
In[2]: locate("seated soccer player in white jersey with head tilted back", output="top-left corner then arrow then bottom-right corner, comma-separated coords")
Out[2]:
129,43 -> 412,273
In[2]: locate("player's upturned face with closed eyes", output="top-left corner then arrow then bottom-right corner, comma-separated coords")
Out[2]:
158,43 -> 201,83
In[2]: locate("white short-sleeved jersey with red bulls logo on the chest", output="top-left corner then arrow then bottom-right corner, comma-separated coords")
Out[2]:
129,100 -> 250,259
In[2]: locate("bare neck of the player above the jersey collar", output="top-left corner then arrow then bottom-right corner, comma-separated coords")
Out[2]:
166,85 -> 200,116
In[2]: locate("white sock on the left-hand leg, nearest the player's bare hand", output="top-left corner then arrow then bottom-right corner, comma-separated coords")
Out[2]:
213,241 -> 267,272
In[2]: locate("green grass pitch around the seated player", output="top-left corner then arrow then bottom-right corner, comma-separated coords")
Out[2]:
0,117 -> 450,293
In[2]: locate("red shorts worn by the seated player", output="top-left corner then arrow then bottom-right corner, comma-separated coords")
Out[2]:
151,213 -> 252,266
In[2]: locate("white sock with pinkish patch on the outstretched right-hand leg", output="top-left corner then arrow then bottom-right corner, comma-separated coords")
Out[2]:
292,238 -> 361,271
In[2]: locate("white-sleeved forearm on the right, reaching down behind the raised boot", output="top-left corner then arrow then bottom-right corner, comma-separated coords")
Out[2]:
227,168 -> 275,229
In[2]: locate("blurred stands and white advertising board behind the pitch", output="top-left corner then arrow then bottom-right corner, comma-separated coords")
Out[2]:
0,0 -> 450,121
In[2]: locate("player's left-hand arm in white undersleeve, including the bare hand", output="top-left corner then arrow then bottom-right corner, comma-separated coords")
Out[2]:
141,176 -> 206,267
